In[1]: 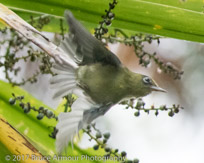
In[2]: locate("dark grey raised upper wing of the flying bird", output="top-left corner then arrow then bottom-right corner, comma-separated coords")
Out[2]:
61,11 -> 121,66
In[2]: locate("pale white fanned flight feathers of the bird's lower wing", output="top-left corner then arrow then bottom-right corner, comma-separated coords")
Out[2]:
56,97 -> 99,153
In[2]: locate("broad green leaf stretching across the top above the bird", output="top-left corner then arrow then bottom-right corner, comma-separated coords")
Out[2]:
1,0 -> 204,42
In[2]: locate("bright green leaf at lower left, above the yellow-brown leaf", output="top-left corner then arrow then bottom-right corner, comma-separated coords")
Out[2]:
0,81 -> 56,155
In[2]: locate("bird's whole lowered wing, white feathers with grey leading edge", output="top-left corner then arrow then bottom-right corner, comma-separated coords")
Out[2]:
56,96 -> 112,153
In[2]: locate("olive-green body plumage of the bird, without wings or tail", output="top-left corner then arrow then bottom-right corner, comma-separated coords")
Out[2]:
77,63 -> 156,104
